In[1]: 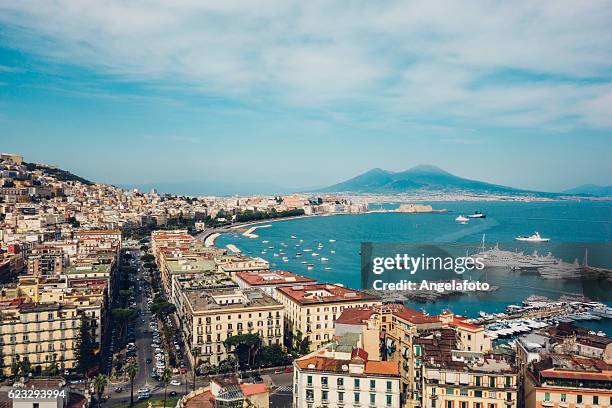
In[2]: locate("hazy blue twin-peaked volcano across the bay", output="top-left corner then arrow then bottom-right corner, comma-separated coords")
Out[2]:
319,165 -> 549,194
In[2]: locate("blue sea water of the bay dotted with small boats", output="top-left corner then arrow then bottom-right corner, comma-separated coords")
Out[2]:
216,201 -> 612,335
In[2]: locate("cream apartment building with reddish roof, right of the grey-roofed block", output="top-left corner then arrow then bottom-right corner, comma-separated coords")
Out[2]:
276,284 -> 382,350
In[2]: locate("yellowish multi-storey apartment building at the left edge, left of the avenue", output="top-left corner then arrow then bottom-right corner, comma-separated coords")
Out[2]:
0,299 -> 80,375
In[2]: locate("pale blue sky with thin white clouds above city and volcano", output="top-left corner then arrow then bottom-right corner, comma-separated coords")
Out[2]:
0,0 -> 612,191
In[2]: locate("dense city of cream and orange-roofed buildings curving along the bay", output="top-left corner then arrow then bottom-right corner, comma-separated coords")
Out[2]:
0,153 -> 612,408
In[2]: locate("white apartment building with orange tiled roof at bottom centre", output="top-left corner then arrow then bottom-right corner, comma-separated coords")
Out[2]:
293,338 -> 400,408
